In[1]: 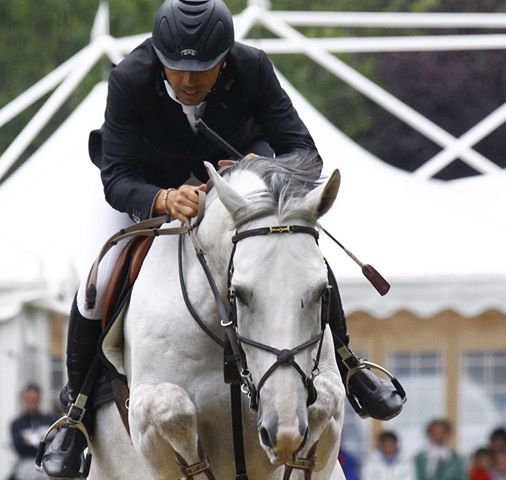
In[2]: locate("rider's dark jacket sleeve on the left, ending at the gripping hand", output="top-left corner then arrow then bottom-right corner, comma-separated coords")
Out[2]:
100,69 -> 160,221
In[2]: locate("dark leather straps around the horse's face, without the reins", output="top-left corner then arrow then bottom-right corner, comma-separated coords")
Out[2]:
222,225 -> 329,411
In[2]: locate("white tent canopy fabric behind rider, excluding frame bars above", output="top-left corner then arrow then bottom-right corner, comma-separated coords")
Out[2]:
0,79 -> 506,316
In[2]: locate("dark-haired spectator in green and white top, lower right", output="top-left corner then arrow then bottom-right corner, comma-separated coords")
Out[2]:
414,419 -> 467,480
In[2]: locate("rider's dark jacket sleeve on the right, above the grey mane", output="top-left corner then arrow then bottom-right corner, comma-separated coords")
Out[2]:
255,52 -> 321,171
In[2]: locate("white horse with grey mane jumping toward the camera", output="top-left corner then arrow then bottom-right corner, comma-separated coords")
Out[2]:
90,155 -> 344,480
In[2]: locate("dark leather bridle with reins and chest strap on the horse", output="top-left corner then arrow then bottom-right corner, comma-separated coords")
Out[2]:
178,225 -> 330,480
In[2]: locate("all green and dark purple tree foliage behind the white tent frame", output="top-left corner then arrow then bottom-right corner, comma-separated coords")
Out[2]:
0,0 -> 506,178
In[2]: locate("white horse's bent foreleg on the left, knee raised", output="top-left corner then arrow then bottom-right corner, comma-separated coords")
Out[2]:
129,383 -> 208,480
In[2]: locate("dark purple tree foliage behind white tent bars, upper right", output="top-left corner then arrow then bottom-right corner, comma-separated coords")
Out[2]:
370,0 -> 506,179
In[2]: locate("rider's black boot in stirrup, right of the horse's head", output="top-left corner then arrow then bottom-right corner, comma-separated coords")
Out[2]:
327,265 -> 405,420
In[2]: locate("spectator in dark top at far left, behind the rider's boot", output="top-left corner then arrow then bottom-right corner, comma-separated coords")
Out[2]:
10,384 -> 56,480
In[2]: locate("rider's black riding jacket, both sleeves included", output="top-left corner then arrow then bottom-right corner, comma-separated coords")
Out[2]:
97,39 -> 319,220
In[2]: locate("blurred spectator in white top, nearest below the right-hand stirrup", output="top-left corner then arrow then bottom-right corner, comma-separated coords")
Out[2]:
362,431 -> 414,480
